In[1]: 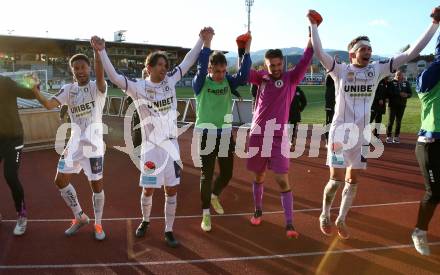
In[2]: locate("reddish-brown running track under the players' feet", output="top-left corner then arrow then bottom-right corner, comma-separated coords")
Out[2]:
0,128 -> 440,274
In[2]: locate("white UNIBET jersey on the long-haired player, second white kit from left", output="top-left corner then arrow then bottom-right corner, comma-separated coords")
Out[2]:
126,66 -> 182,147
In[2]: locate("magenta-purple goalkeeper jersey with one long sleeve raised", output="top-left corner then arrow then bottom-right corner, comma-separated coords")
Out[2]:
249,48 -> 313,136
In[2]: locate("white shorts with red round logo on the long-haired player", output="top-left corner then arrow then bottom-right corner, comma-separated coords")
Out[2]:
139,139 -> 182,188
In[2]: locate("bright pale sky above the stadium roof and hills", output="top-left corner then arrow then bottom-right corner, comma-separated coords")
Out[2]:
0,0 -> 440,56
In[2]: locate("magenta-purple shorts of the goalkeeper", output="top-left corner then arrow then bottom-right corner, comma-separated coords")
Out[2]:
247,135 -> 290,174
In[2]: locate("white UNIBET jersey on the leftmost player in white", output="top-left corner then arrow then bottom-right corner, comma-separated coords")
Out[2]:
53,81 -> 107,160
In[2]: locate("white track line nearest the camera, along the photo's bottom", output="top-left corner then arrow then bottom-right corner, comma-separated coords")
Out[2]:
0,242 -> 440,270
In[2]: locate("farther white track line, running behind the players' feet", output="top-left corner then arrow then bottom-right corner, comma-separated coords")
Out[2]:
3,201 -> 420,223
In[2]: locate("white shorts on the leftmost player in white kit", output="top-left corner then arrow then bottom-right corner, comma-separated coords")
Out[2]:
57,155 -> 104,181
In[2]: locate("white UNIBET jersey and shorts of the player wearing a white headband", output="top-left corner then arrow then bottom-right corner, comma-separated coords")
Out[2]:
327,59 -> 393,168
